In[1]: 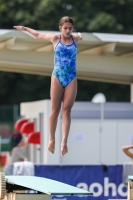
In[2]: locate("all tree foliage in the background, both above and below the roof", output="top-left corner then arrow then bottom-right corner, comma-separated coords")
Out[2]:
0,0 -> 133,104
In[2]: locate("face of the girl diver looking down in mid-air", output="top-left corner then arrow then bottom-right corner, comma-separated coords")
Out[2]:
59,22 -> 73,37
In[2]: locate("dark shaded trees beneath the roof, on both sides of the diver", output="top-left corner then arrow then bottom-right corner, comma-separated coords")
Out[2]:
0,72 -> 130,105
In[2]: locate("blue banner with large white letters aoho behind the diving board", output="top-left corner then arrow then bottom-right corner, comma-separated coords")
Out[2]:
35,165 -> 127,200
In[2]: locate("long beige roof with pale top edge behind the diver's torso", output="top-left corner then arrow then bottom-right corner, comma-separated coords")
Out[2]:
0,29 -> 133,84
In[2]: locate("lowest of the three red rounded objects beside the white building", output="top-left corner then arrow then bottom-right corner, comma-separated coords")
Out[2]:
27,132 -> 40,144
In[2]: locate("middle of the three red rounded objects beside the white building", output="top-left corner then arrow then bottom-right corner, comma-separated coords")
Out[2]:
20,122 -> 34,134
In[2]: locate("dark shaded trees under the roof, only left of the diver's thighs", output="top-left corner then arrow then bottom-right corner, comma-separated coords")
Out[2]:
0,72 -> 50,104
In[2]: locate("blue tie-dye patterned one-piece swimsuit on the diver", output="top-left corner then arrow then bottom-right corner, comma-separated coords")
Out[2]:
52,35 -> 77,88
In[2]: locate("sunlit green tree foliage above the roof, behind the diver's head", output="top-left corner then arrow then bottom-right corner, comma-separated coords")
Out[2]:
0,0 -> 133,34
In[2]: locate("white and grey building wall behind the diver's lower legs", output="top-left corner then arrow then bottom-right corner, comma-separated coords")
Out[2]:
21,100 -> 133,165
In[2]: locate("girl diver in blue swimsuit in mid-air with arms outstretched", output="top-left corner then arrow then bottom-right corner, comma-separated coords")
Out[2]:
14,16 -> 82,155
